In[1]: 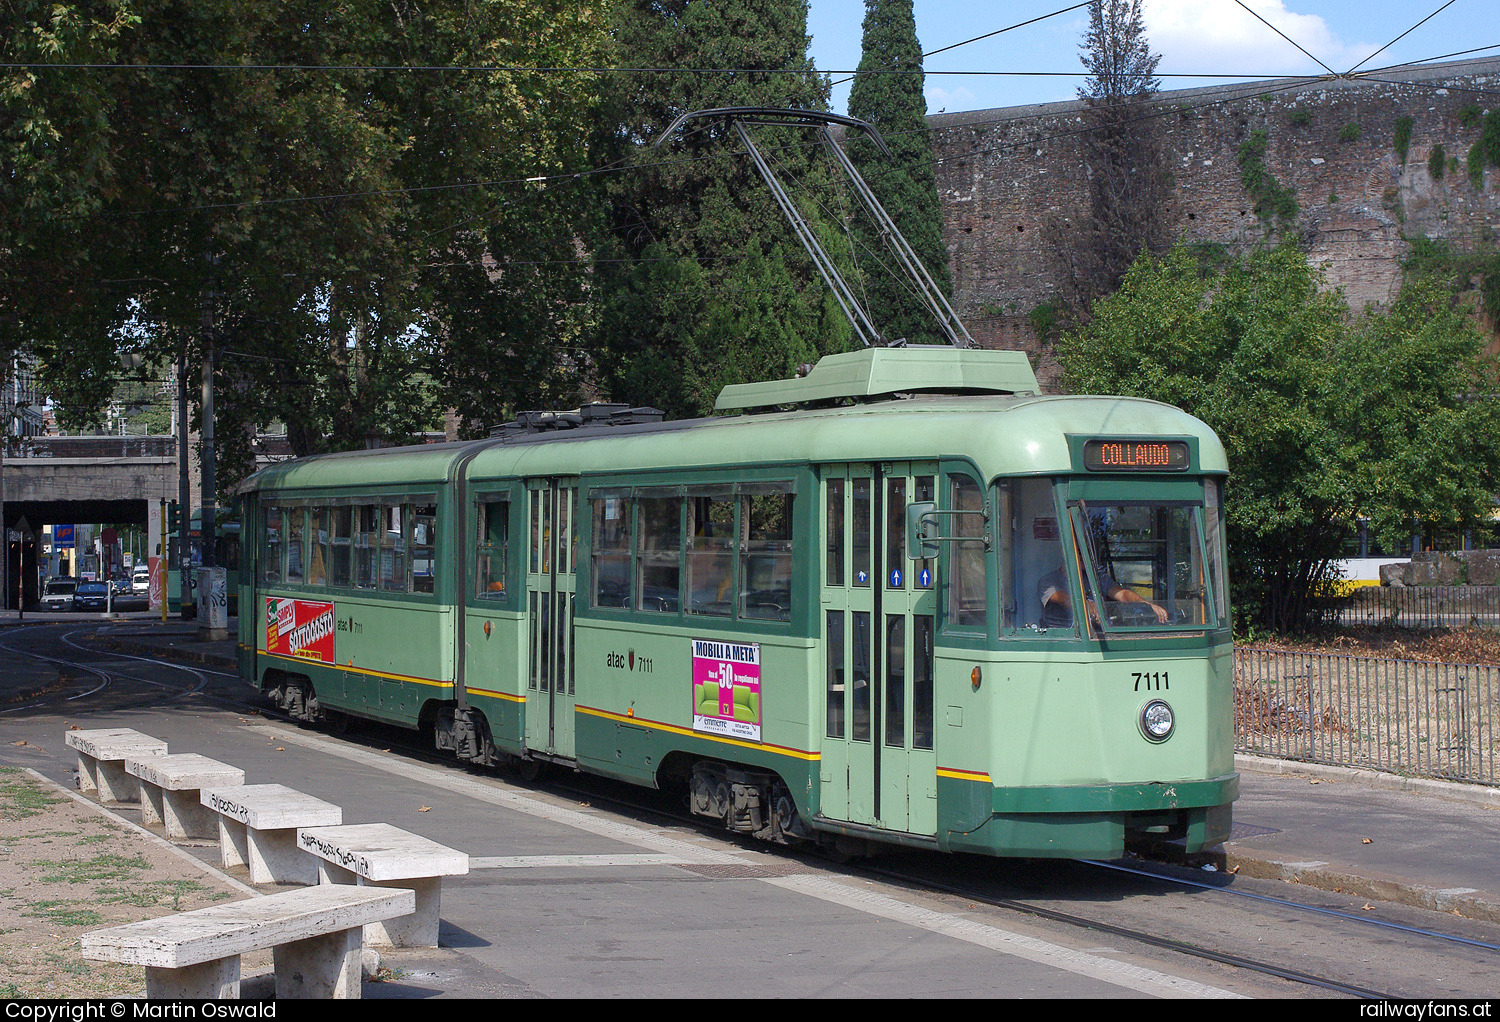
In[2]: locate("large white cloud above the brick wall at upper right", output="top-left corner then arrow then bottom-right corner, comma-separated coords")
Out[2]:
1142,0 -> 1377,79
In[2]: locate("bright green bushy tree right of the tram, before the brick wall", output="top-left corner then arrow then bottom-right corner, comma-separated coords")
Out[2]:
1059,246 -> 1500,630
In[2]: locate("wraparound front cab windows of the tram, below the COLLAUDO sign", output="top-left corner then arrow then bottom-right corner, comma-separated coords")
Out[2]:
1007,480 -> 1227,635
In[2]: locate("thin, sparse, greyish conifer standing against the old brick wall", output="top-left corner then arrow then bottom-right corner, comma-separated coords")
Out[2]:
1068,0 -> 1172,312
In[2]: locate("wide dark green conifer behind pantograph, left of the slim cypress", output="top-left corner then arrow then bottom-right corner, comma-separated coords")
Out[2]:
591,0 -> 849,416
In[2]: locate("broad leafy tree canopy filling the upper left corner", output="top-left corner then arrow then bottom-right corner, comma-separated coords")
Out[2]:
0,0 -> 608,479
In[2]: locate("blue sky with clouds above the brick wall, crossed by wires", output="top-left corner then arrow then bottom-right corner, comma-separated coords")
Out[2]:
807,0 -> 1500,114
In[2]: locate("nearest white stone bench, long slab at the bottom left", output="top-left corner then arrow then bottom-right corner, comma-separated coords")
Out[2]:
81,884 -> 416,999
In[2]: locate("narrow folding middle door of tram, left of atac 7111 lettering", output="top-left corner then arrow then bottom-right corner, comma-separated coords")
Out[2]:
527,479 -> 578,756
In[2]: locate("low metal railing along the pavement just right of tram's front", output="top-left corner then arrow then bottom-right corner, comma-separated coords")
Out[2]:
1235,647 -> 1500,785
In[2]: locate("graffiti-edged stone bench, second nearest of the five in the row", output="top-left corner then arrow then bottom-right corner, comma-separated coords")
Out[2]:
297,824 -> 468,947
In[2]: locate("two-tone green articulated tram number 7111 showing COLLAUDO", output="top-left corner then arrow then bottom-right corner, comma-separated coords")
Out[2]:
239,347 -> 1239,858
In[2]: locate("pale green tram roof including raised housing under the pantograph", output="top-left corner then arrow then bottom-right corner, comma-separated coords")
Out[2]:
242,347 -> 1227,491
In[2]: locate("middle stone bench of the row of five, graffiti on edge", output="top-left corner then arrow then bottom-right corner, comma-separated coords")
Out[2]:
200,785 -> 344,884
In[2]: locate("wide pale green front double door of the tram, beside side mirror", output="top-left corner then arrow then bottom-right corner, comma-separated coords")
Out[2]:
821,462 -> 938,834
